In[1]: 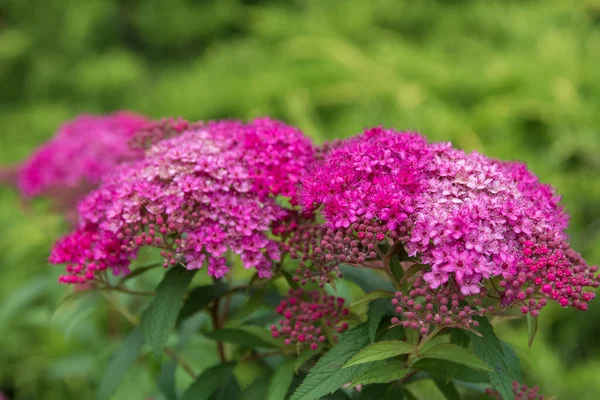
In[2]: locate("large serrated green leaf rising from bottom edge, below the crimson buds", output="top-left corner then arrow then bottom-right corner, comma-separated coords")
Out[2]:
290,325 -> 373,400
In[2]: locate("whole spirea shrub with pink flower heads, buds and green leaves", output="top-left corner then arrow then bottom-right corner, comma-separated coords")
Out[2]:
5,114 -> 599,400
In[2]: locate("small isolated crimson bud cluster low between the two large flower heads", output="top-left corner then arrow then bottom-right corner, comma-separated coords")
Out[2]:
271,289 -> 348,350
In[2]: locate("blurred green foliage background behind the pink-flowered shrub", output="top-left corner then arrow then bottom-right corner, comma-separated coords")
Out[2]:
0,0 -> 600,400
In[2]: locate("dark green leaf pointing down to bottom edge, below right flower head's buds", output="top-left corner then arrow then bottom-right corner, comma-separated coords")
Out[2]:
468,317 -> 516,400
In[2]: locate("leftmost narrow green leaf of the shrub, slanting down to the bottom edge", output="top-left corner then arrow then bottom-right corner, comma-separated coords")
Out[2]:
96,327 -> 144,400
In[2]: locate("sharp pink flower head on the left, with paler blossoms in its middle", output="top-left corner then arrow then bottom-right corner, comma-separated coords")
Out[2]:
50,118 -> 313,283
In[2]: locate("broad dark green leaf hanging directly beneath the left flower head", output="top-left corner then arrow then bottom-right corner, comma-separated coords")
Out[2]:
141,266 -> 196,358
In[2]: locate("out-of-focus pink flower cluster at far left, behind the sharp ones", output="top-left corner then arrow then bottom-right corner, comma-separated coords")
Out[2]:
18,112 -> 146,197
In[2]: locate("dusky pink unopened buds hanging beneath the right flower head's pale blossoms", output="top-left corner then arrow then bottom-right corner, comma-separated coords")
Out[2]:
391,273 -> 492,336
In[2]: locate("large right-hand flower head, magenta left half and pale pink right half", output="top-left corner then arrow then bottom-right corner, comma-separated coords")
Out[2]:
298,128 -> 599,315
